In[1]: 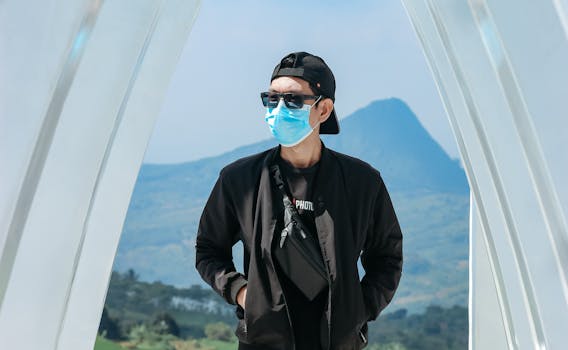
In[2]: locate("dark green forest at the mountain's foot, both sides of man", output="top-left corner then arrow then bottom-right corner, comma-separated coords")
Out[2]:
95,269 -> 468,350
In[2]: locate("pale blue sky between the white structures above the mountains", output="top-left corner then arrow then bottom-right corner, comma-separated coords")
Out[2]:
144,0 -> 458,163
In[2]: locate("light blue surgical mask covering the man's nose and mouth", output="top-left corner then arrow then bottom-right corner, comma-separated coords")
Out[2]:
264,98 -> 319,147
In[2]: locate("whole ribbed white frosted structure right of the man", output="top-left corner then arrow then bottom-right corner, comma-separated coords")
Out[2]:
403,0 -> 568,349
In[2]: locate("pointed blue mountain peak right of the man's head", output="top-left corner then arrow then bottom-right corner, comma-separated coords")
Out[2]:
323,98 -> 468,192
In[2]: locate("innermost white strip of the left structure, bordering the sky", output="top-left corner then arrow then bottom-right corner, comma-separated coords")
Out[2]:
58,0 -> 198,350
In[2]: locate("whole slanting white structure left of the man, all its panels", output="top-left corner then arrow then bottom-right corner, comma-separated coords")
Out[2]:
0,0 -> 202,349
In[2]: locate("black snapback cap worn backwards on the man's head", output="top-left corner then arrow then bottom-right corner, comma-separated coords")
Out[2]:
270,52 -> 339,134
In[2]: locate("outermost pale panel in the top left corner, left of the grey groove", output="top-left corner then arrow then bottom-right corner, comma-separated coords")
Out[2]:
0,0 -> 89,282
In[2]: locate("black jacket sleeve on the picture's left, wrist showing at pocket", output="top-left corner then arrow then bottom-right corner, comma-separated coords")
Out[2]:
195,171 -> 247,304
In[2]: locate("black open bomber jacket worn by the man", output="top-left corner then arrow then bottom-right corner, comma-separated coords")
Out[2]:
195,146 -> 402,350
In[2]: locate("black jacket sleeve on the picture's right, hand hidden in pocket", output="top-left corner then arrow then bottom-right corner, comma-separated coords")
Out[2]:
361,178 -> 402,321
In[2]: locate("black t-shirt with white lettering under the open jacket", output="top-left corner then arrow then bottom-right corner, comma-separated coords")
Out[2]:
275,157 -> 327,350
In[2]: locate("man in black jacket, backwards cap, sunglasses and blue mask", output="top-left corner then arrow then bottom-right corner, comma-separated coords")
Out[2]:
196,52 -> 402,350
